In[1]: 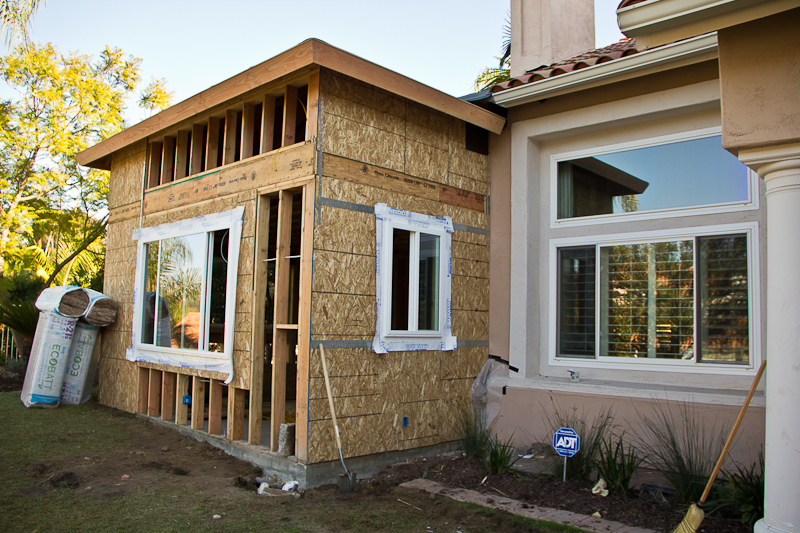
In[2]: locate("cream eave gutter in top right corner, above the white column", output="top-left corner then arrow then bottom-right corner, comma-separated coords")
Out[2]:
617,0 -> 800,49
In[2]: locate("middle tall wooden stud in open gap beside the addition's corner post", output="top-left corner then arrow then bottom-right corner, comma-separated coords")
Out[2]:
269,191 -> 294,452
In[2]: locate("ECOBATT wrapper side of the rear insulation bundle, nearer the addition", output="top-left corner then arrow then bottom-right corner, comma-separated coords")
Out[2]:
61,322 -> 100,405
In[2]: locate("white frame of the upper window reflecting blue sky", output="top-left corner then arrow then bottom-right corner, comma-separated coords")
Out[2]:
550,126 -> 759,229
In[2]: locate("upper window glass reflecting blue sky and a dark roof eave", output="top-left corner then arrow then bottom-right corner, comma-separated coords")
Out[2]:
554,132 -> 756,223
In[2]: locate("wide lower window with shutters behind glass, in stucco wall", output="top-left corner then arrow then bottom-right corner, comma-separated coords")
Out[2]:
554,224 -> 756,366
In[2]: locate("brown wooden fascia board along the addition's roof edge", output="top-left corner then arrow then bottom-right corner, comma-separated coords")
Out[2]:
78,39 -> 505,170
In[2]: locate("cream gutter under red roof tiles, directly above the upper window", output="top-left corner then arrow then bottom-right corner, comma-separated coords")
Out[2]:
493,33 -> 718,107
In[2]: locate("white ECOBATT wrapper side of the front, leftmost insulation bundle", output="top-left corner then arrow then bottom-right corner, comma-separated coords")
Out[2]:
20,311 -> 77,407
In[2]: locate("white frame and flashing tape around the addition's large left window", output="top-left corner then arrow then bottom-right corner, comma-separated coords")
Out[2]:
126,206 -> 244,384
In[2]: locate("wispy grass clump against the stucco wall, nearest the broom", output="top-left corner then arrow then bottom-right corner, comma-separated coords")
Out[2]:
633,402 -> 728,502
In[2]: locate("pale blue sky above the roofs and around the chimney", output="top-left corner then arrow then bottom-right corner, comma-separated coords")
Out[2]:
14,0 -> 621,122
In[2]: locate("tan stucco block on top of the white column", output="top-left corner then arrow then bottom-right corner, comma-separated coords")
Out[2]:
718,8 -> 800,153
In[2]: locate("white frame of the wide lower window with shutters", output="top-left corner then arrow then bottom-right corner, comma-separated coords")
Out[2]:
548,222 -> 761,375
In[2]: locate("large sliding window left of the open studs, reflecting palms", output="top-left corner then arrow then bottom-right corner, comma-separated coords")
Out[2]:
128,207 -> 244,376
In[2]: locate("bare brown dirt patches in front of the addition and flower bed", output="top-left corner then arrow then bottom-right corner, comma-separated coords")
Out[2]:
0,370 -> 749,533
